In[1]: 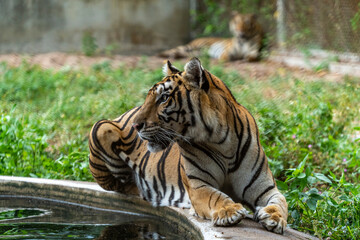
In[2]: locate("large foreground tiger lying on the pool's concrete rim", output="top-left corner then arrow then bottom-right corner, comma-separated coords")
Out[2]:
89,58 -> 288,233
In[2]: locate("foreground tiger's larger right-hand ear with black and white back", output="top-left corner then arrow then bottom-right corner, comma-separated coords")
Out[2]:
184,57 -> 209,91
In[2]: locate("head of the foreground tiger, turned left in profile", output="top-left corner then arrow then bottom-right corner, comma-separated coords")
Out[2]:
133,58 -> 233,152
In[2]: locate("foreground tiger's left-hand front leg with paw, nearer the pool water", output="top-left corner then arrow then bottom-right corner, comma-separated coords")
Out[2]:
181,161 -> 247,226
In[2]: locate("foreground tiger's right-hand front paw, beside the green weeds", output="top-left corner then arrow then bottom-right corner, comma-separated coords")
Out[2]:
254,205 -> 287,234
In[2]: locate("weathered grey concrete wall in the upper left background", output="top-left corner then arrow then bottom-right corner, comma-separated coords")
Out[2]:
0,0 -> 190,54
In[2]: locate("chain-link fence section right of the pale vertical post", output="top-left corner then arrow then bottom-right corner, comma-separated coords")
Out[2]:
277,0 -> 360,54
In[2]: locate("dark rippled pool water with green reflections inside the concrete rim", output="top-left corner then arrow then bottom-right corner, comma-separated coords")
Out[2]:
0,195 -> 193,240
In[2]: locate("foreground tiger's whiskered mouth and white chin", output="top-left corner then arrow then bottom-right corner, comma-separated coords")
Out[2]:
138,127 -> 174,152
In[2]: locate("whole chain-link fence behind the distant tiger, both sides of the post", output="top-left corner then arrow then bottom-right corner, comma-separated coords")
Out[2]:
193,0 -> 360,55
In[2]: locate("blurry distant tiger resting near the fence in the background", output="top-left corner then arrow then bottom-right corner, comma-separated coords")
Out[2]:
158,12 -> 264,62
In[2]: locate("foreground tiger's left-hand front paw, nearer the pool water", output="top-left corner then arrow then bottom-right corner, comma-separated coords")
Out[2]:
212,203 -> 247,226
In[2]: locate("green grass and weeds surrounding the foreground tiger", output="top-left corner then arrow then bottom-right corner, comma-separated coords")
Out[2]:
0,61 -> 360,239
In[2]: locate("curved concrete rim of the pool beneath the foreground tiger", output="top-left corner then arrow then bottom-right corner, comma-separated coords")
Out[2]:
0,176 -> 317,240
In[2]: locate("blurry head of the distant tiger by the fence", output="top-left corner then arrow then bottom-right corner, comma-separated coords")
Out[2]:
229,12 -> 261,39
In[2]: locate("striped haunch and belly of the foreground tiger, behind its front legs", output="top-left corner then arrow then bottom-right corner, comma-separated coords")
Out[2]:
89,107 -> 191,208
